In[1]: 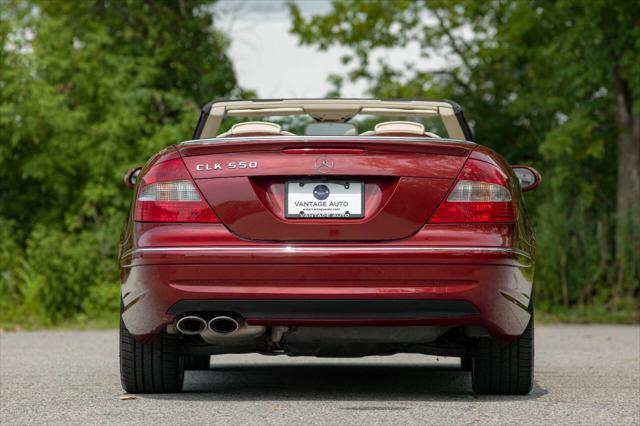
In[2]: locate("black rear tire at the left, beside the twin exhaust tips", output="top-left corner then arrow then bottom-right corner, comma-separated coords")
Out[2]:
120,317 -> 184,393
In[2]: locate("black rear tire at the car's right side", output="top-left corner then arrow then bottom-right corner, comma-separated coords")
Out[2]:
471,312 -> 534,395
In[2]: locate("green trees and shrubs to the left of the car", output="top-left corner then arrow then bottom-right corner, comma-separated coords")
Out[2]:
0,0 -> 241,325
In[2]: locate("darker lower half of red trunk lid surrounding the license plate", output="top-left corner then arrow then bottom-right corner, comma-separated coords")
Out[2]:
196,177 -> 453,241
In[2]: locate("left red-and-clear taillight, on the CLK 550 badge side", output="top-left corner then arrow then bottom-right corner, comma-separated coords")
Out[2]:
133,158 -> 219,222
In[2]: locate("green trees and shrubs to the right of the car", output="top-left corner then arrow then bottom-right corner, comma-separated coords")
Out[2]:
290,0 -> 640,312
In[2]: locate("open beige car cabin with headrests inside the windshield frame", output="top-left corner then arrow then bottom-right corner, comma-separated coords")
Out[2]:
192,99 -> 464,141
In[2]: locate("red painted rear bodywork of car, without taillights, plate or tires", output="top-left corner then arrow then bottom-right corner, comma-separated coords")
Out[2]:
120,140 -> 535,340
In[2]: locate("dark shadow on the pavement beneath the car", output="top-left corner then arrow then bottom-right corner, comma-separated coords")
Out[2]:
141,363 -> 547,402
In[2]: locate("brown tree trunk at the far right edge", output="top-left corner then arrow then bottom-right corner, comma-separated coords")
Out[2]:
613,72 -> 640,296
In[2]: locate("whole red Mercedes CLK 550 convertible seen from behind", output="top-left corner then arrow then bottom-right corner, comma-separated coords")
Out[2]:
120,99 -> 540,394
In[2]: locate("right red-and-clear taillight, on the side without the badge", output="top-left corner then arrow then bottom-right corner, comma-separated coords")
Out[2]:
429,158 -> 514,223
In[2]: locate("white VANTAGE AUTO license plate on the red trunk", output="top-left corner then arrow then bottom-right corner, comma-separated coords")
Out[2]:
285,180 -> 364,219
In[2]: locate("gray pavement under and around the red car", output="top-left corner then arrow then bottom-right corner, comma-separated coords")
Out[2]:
0,326 -> 640,425
